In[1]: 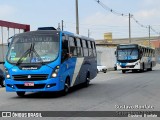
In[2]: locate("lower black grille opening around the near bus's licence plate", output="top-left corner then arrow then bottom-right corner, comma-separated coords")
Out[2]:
16,84 -> 45,89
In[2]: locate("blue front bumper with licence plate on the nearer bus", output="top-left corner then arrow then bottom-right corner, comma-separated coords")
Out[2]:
5,77 -> 64,92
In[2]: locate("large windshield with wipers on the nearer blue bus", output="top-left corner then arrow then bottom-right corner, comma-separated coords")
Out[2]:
7,31 -> 59,63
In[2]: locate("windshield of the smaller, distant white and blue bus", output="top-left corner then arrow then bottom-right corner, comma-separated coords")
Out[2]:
117,49 -> 138,60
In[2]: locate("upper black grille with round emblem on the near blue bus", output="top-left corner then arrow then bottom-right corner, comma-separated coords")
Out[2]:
12,74 -> 48,81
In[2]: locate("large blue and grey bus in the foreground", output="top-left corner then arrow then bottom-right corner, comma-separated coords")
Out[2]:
4,28 -> 97,96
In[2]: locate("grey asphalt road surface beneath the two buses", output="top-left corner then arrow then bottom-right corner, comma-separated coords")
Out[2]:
0,65 -> 160,120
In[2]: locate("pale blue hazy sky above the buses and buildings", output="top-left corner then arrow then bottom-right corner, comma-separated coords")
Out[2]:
0,0 -> 160,39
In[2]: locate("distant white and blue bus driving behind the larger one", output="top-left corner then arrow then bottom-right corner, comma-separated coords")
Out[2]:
116,44 -> 156,73
